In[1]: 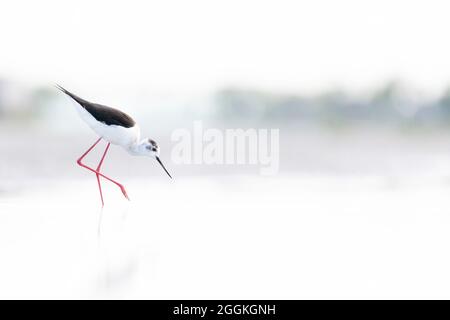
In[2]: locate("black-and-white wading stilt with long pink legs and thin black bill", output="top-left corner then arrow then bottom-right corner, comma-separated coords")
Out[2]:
55,84 -> 172,207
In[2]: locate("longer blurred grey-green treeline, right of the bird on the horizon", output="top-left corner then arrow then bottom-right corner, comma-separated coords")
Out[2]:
215,82 -> 450,129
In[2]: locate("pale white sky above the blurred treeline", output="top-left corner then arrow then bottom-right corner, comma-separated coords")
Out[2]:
0,0 -> 450,92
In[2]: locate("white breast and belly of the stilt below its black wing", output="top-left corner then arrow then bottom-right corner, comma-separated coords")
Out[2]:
74,102 -> 141,150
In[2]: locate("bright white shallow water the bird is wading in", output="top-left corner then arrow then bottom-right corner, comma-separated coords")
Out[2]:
0,175 -> 450,299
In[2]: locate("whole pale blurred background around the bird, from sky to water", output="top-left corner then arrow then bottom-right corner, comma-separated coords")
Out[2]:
0,0 -> 450,299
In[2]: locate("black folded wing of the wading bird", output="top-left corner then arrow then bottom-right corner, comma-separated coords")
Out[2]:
56,85 -> 136,128
